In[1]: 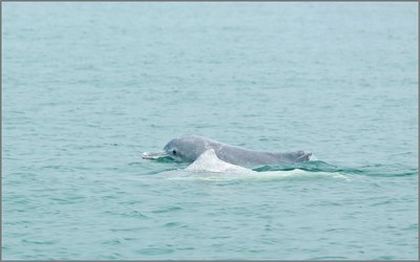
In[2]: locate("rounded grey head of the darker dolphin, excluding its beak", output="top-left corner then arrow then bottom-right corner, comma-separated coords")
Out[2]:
163,136 -> 209,162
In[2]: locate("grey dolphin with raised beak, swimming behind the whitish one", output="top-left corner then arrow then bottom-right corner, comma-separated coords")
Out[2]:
143,135 -> 312,167
